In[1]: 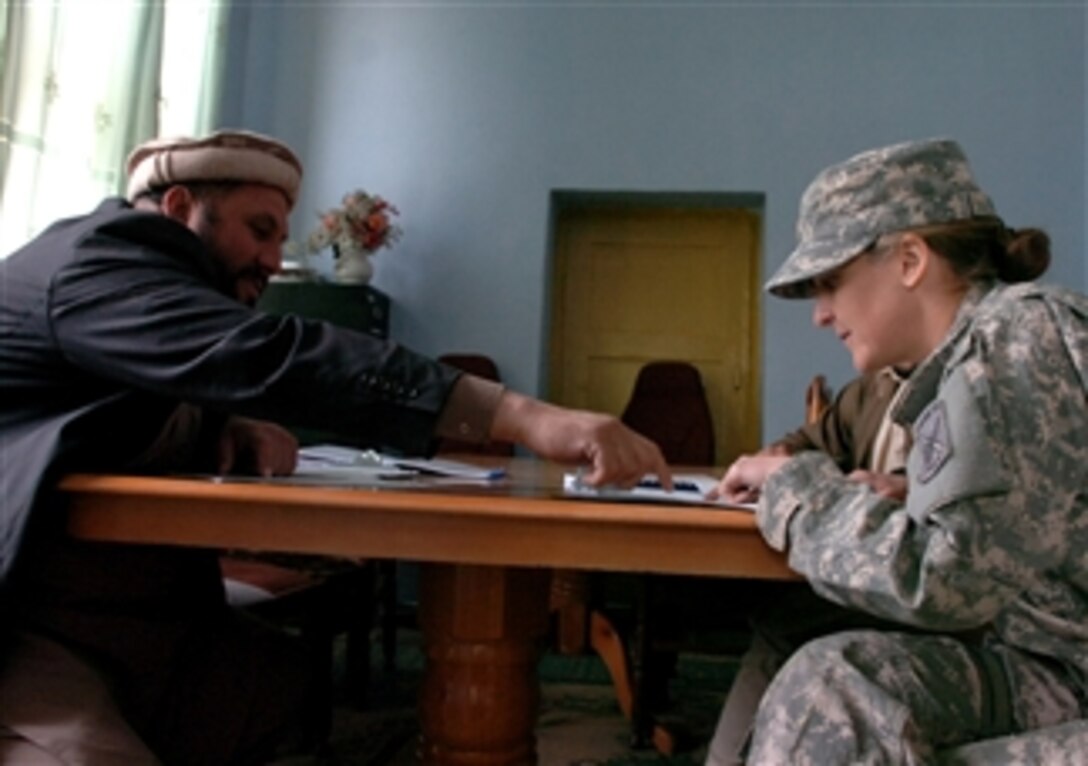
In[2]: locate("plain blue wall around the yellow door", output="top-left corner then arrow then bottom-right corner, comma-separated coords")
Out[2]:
218,0 -> 1088,446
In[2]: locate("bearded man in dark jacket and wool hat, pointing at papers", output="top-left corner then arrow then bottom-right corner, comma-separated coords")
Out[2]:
0,132 -> 668,766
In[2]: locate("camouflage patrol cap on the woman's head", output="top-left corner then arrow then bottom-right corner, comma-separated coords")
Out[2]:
766,139 -> 997,298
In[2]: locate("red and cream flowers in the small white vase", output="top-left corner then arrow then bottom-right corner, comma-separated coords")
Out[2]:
306,189 -> 401,258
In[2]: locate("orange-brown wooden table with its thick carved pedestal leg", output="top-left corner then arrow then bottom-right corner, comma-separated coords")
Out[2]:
61,458 -> 796,766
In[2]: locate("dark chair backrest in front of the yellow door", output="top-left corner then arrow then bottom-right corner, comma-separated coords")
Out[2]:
620,361 -> 714,466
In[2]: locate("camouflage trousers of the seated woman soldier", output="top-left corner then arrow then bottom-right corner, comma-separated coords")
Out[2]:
747,630 -> 1083,766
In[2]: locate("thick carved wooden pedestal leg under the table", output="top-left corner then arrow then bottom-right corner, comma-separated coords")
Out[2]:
419,564 -> 549,766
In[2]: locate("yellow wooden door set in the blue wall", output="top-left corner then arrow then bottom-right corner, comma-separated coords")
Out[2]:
548,204 -> 762,465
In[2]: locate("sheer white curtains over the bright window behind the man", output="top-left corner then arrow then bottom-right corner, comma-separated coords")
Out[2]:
0,0 -> 226,258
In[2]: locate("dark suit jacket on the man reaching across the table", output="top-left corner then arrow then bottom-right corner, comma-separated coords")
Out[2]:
0,200 -> 459,577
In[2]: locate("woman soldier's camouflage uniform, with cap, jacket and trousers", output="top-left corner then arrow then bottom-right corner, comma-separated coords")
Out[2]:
735,141 -> 1088,766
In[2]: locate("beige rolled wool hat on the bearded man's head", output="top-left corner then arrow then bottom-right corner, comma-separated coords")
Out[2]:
125,131 -> 302,206
